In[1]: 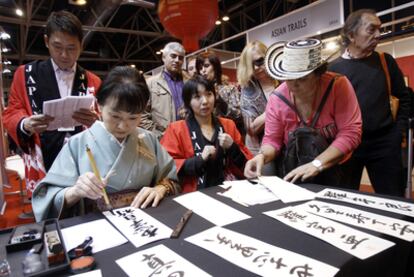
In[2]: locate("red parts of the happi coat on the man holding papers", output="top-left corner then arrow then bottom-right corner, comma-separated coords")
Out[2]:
3,65 -> 101,196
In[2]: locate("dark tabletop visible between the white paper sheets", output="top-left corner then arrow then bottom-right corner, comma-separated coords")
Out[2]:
2,184 -> 414,277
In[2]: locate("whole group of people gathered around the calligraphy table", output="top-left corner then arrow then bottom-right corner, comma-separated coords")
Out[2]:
3,9 -> 411,220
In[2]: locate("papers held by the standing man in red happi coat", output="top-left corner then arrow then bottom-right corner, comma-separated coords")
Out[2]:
43,94 -> 95,130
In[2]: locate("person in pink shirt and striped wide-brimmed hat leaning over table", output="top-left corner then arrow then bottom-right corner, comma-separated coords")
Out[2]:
245,39 -> 362,186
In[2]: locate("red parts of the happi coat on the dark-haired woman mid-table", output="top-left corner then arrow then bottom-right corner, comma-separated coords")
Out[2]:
161,117 -> 253,192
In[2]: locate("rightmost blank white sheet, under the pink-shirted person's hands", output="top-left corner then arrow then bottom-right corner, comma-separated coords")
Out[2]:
259,176 -> 316,203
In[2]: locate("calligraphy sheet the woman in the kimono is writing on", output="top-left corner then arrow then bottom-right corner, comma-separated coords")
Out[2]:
103,207 -> 172,247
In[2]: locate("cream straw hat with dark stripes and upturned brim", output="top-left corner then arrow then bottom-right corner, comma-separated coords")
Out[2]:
265,38 -> 339,81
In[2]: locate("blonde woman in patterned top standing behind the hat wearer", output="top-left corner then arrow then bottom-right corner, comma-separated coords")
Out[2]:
237,41 -> 278,165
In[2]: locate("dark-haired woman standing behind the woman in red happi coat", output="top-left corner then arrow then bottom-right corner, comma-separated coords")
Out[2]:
196,52 -> 245,135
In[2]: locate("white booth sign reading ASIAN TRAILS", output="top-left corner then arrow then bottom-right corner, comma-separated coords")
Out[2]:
247,0 -> 344,46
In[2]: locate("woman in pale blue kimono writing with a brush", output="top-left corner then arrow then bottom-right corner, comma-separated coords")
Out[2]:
32,66 -> 181,221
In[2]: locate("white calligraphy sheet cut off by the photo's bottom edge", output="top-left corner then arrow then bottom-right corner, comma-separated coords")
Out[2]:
116,245 -> 211,277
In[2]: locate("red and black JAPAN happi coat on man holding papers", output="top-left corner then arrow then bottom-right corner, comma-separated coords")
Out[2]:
3,59 -> 101,196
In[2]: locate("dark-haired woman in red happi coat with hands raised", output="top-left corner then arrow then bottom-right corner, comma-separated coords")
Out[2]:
161,76 -> 252,192
